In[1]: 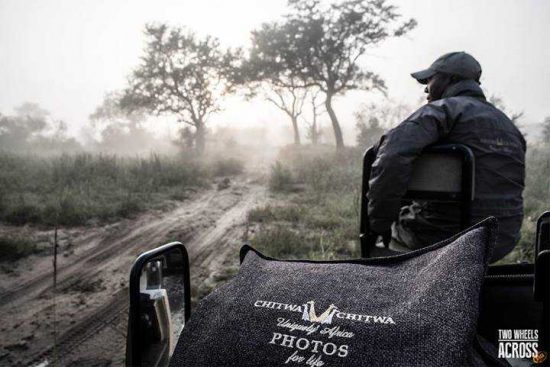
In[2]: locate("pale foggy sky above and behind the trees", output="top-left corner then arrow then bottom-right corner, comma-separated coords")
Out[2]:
0,0 -> 550,143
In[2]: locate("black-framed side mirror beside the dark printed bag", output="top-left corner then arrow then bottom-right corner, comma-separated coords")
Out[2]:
126,242 -> 191,367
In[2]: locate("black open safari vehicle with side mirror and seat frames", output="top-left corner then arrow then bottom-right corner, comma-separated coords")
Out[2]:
126,144 -> 550,366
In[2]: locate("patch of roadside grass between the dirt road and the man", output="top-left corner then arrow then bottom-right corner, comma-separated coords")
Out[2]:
248,146 -> 362,260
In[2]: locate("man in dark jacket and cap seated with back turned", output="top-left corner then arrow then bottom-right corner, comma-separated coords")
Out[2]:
368,52 -> 526,260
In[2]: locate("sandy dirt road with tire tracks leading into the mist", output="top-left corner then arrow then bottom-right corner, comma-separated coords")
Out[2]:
0,178 -> 266,366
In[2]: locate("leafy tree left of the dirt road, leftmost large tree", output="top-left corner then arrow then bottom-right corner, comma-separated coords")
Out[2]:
121,25 -> 233,154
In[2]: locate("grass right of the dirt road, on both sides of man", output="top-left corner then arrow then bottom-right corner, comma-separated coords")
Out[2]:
248,144 -> 550,263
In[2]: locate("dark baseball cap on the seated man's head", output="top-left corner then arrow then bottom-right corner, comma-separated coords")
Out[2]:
411,51 -> 481,84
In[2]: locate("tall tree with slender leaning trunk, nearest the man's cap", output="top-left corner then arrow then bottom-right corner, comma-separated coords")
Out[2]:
258,0 -> 416,149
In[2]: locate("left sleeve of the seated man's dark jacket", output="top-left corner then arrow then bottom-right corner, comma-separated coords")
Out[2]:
367,100 -> 460,233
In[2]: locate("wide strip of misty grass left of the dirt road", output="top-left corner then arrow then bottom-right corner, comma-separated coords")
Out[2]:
0,153 -> 243,227
